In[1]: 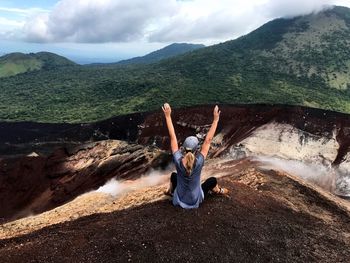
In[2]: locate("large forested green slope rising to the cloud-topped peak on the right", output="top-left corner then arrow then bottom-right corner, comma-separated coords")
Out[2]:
0,4 -> 350,122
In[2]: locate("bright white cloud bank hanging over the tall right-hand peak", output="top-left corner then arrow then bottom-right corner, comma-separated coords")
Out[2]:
150,0 -> 350,43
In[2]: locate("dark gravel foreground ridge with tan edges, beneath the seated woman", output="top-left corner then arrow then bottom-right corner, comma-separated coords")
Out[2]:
0,159 -> 350,262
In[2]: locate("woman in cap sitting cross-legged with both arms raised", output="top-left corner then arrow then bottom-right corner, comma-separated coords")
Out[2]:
162,103 -> 228,209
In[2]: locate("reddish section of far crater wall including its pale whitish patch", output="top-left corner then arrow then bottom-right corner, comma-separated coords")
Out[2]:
138,105 -> 350,166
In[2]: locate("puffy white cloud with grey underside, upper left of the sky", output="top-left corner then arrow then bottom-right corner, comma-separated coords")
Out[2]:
25,0 -> 177,43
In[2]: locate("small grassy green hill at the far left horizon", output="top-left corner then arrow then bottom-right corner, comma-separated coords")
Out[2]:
0,52 -> 76,78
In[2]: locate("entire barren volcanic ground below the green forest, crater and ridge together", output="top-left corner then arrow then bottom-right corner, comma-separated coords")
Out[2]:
0,105 -> 350,262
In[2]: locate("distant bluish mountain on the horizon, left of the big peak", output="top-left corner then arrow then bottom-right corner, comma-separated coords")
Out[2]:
116,43 -> 205,65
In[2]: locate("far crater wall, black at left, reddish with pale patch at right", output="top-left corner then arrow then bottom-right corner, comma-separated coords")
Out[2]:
0,105 -> 350,165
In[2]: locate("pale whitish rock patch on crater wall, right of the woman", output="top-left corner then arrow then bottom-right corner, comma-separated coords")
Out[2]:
230,122 -> 339,166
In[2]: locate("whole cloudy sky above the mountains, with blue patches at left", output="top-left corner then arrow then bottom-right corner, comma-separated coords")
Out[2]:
0,0 -> 350,63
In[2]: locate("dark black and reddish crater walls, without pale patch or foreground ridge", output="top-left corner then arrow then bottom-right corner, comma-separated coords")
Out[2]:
0,105 -> 350,223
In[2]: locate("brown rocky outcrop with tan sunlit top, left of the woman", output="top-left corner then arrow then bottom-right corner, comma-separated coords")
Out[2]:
0,140 -> 171,221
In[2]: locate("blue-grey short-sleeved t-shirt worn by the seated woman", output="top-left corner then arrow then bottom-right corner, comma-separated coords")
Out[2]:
173,150 -> 204,209
